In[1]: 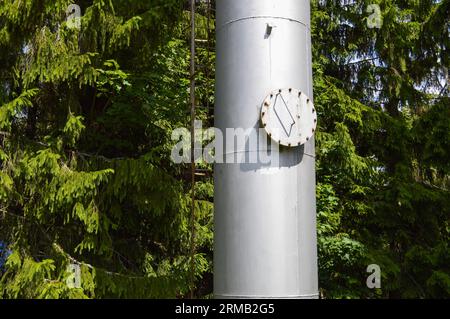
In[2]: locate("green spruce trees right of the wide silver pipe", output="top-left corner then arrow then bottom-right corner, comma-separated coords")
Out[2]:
313,0 -> 450,298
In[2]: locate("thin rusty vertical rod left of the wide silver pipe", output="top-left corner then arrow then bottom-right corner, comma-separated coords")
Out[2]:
190,0 -> 196,299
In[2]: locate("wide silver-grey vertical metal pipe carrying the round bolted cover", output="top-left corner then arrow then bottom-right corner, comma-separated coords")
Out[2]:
214,0 -> 318,298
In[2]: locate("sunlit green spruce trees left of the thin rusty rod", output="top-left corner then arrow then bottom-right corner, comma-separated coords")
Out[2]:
0,0 -> 212,298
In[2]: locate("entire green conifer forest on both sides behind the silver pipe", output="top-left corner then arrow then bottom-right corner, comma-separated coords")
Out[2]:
0,0 -> 450,298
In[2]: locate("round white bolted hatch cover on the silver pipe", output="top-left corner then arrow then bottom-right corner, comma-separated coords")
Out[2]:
261,89 -> 317,147
